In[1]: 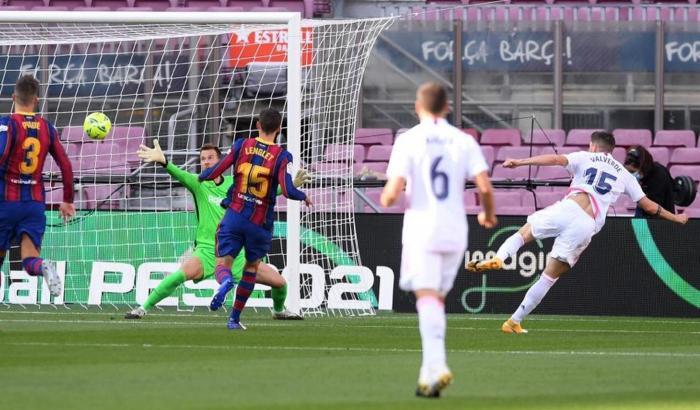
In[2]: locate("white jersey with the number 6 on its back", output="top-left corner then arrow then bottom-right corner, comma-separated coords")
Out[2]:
387,119 -> 488,252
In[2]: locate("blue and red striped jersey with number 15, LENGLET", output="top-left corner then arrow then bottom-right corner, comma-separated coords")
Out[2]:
199,138 -> 306,230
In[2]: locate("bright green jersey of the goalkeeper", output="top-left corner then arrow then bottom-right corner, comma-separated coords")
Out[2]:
165,162 -> 233,249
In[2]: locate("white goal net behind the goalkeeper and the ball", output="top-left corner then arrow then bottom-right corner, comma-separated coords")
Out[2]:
0,12 -> 392,314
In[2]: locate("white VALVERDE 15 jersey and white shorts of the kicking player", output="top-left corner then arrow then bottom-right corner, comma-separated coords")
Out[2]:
527,151 -> 645,266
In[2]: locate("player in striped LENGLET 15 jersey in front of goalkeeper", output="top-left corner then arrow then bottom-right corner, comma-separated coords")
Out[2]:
199,109 -> 311,330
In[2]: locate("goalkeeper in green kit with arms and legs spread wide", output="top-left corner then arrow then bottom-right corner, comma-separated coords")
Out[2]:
125,139 -> 310,320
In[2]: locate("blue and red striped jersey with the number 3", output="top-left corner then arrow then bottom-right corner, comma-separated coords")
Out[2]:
0,112 -> 73,203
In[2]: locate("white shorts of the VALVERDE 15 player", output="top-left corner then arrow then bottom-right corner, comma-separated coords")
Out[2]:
527,199 -> 596,267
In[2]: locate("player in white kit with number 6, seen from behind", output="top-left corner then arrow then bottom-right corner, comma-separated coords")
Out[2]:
380,83 -> 497,397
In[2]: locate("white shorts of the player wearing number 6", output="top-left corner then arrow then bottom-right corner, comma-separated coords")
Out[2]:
399,244 -> 466,296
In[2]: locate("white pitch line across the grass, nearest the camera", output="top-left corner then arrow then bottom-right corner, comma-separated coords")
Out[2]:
0,342 -> 700,358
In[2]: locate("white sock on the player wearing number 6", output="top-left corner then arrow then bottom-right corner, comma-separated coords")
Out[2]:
416,296 -> 447,369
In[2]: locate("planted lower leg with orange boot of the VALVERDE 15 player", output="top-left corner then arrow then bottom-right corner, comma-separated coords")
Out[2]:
501,258 -> 569,333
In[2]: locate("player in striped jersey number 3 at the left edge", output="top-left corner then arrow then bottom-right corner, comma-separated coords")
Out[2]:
0,75 -> 75,296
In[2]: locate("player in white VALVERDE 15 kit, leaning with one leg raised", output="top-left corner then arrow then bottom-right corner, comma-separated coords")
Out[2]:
467,131 -> 688,333
